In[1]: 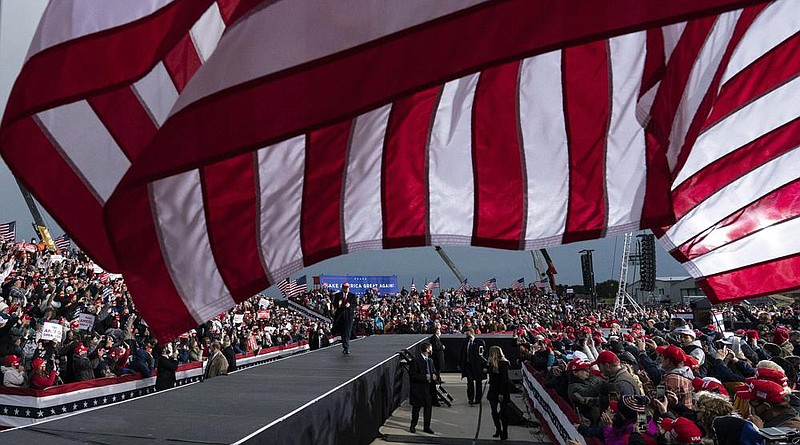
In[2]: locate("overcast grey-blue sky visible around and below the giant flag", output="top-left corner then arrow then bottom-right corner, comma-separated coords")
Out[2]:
0,0 -> 688,295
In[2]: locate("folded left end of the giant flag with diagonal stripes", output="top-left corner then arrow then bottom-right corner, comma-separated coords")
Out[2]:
0,0 -> 239,268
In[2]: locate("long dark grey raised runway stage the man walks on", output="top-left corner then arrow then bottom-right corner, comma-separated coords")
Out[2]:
0,335 -> 428,445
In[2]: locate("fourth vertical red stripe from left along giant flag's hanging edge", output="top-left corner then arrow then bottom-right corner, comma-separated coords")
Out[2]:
380,87 -> 441,249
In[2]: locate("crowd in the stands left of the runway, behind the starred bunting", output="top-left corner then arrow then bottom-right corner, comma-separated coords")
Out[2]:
0,243 -> 330,389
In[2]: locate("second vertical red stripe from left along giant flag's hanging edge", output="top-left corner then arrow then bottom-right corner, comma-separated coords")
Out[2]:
200,153 -> 269,302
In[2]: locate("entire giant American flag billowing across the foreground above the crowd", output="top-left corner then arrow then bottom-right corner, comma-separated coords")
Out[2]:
0,0 -> 800,339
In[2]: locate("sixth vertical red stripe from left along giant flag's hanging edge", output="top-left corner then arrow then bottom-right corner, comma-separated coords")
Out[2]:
562,41 -> 612,243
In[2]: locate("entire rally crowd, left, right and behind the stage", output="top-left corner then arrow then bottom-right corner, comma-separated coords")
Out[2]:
6,234 -> 800,445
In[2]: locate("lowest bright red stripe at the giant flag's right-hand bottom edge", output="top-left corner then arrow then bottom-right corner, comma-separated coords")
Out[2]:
697,253 -> 800,301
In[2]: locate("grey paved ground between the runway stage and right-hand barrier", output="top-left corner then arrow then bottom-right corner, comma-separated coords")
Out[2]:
372,374 -> 549,445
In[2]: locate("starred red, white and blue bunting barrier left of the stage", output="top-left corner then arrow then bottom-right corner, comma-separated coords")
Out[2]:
0,337 -> 324,429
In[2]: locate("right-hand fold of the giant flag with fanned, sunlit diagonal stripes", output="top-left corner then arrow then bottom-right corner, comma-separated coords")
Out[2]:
653,2 -> 800,301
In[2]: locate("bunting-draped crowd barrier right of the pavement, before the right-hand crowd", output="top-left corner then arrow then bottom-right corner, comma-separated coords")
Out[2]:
522,363 -> 591,445
